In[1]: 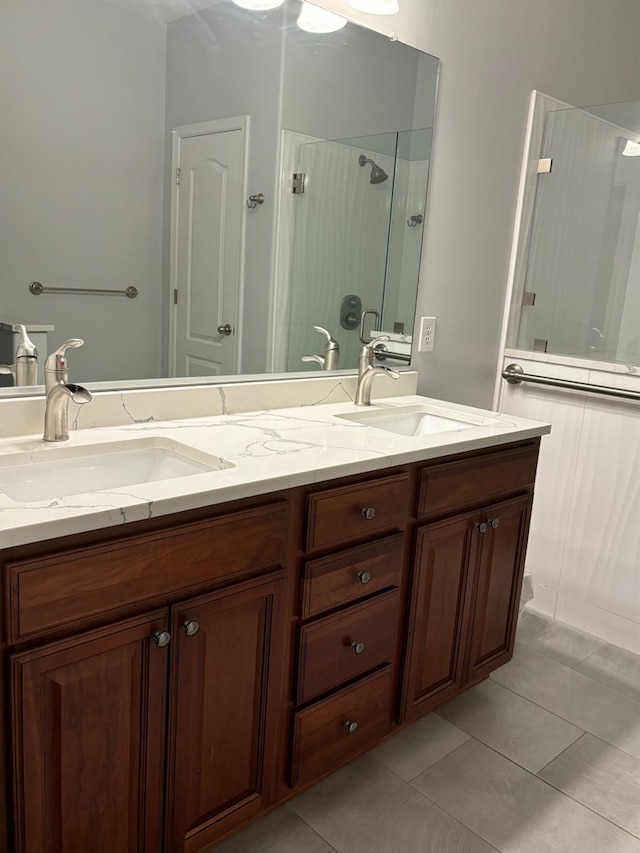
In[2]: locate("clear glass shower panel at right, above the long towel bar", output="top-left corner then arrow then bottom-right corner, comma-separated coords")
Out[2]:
510,102 -> 640,366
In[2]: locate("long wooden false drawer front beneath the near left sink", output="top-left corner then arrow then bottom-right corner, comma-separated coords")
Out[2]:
7,503 -> 287,642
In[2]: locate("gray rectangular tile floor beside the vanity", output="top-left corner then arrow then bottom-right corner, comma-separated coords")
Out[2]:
215,612 -> 640,853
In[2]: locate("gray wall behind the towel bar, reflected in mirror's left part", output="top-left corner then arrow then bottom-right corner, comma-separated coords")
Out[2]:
0,0 -> 165,382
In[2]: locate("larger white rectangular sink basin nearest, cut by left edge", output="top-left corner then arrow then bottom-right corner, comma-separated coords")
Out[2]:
0,437 -> 235,503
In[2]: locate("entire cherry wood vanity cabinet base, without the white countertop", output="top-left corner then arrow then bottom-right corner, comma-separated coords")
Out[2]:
0,439 -> 539,853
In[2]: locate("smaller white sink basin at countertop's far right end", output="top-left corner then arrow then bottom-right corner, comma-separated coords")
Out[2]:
336,404 -> 496,436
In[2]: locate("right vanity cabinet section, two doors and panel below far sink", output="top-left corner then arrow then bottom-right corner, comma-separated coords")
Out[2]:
400,447 -> 537,722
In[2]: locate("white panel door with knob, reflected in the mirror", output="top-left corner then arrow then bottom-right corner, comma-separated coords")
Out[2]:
173,130 -> 244,376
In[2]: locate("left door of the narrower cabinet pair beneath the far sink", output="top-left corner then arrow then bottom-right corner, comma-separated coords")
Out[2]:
401,512 -> 479,722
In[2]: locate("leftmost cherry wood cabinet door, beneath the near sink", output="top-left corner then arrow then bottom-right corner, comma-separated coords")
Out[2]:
11,610 -> 168,853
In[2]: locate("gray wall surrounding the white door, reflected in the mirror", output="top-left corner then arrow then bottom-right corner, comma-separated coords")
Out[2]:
163,4 -> 282,373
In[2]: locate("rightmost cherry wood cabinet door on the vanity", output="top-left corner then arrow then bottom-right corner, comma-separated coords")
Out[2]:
465,495 -> 533,682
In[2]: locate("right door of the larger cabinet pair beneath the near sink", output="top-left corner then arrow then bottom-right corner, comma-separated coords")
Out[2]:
166,572 -> 284,853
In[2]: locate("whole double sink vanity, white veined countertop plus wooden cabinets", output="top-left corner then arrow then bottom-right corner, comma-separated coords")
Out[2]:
0,372 -> 549,853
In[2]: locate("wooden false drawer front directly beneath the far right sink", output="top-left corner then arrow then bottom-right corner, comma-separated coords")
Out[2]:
418,444 -> 538,517
